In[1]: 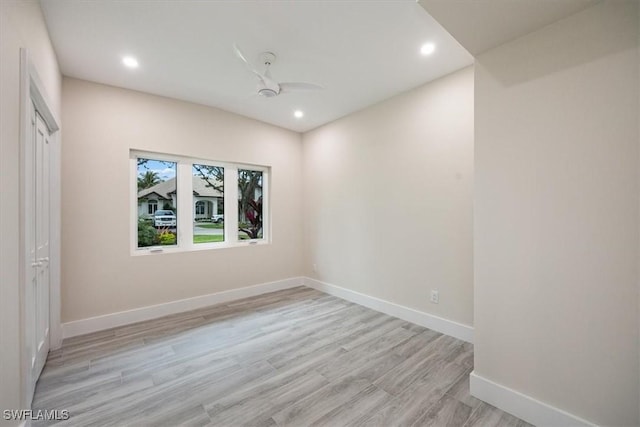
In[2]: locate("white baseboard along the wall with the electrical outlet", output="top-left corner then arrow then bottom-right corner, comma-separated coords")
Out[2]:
304,277 -> 473,343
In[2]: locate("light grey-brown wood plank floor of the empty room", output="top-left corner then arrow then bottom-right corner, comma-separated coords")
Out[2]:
33,287 -> 528,427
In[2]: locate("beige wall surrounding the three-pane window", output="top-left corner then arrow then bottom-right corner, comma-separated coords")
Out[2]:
62,78 -> 302,322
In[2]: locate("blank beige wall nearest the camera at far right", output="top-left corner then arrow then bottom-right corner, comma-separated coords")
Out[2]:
474,1 -> 640,426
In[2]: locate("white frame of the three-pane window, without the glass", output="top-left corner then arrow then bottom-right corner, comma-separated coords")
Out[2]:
129,149 -> 271,256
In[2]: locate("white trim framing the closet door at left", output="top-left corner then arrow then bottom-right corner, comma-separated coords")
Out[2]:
19,49 -> 62,407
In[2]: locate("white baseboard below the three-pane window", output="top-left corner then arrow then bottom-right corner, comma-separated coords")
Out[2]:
62,277 -> 304,338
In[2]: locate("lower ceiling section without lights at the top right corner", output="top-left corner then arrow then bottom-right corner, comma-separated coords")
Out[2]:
419,0 -> 600,55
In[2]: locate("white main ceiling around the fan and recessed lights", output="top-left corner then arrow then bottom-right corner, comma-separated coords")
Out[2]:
41,0 -> 473,132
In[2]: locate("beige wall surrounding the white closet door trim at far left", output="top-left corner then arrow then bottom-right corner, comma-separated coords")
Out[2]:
0,0 -> 60,425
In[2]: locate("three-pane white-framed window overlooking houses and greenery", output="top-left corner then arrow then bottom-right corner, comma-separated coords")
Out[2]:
131,151 -> 269,254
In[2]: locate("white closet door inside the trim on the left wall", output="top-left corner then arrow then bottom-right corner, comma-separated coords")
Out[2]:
25,99 -> 50,395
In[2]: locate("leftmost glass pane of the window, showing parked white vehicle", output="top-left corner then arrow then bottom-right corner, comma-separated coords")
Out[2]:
136,157 -> 178,248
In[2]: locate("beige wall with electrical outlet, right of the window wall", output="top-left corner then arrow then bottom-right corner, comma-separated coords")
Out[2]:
303,68 -> 473,325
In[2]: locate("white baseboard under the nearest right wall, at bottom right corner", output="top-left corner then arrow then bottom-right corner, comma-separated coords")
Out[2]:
469,371 -> 596,427
